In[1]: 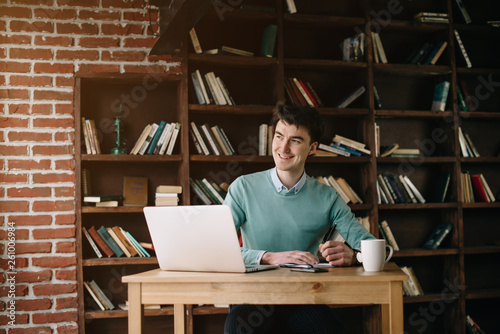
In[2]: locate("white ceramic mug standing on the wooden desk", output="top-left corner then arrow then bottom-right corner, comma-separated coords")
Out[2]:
357,239 -> 394,271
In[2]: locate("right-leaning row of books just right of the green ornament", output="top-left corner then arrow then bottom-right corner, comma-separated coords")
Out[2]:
130,120 -> 181,155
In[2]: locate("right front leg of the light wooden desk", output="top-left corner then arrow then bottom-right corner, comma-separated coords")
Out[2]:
382,282 -> 404,334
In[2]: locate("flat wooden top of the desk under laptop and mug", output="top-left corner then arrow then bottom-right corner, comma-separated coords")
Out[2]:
122,262 -> 408,283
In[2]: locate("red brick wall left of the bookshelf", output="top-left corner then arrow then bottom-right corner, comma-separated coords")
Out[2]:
0,0 -> 179,334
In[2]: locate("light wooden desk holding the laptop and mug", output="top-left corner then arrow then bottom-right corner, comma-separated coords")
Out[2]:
122,263 -> 408,334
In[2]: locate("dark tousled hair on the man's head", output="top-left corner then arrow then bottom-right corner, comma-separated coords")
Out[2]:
271,105 -> 325,144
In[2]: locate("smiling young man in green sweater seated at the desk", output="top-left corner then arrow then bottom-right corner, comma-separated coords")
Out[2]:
224,106 -> 373,334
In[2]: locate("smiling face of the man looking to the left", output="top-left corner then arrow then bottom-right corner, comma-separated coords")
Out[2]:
272,121 -> 318,173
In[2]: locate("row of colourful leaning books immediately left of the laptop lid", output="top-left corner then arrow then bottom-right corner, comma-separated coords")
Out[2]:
82,226 -> 151,258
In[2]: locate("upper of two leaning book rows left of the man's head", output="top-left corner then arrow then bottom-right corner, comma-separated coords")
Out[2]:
191,70 -> 235,106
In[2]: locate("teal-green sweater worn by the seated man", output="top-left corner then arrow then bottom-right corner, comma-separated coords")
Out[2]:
224,170 -> 374,264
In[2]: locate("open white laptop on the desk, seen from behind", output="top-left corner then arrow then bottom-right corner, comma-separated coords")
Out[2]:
144,205 -> 278,273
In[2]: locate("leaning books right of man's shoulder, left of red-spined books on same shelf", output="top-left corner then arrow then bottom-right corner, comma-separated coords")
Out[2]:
377,173 -> 425,204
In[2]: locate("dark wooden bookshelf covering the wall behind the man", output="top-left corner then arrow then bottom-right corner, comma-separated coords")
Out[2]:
75,0 -> 500,334
